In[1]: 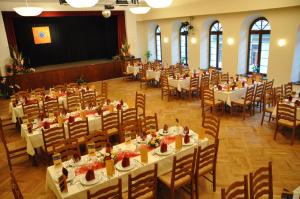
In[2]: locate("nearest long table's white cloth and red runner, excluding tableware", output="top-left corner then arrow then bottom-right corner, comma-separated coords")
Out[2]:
46,127 -> 209,199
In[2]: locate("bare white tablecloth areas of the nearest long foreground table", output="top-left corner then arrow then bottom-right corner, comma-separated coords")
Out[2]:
46,129 -> 208,199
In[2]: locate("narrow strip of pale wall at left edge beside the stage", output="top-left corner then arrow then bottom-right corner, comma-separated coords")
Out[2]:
0,14 -> 10,76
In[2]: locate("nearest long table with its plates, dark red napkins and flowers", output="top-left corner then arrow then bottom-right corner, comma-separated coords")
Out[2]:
46,122 -> 208,198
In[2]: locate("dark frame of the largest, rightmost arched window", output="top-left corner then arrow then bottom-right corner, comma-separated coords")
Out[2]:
247,17 -> 271,76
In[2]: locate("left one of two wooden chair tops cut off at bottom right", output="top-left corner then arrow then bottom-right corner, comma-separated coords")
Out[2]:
221,175 -> 249,199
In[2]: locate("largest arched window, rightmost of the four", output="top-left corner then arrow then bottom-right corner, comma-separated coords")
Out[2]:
247,18 -> 271,74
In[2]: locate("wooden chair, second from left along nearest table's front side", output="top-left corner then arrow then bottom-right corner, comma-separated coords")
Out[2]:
123,164 -> 157,199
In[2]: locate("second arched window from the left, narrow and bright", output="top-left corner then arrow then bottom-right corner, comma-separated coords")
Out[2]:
179,26 -> 188,65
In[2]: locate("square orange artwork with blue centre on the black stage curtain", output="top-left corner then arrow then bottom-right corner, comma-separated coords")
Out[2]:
32,26 -> 51,44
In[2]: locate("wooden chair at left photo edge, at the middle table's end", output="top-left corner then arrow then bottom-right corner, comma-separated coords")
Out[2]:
0,118 -> 28,170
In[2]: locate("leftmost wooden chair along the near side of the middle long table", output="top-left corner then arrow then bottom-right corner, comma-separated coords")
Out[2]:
42,127 -> 66,165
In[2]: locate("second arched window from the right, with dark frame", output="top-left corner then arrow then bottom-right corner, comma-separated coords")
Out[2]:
209,21 -> 223,68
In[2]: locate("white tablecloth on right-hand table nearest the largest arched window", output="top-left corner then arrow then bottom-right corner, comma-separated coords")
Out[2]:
214,87 -> 247,106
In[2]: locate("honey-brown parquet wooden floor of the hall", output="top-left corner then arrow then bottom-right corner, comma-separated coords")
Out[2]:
0,79 -> 300,199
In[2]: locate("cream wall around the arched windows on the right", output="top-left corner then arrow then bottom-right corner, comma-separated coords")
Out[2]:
138,6 -> 300,84
